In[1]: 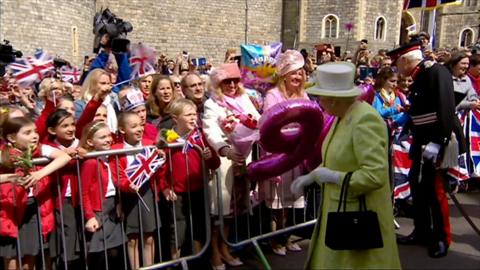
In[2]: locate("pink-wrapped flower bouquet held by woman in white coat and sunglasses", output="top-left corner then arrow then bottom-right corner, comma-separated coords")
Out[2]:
219,114 -> 260,158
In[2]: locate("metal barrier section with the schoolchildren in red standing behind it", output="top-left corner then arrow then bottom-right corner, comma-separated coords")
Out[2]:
3,143 -> 211,269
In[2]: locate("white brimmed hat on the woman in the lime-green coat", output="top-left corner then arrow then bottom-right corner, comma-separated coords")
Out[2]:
306,62 -> 362,97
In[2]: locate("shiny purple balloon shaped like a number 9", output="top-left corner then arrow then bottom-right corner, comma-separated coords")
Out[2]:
247,99 -> 324,180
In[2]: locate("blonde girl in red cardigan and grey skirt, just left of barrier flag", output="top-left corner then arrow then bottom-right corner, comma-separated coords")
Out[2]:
80,121 -> 124,269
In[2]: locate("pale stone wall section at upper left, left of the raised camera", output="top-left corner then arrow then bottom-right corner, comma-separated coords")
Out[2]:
0,0 -> 95,64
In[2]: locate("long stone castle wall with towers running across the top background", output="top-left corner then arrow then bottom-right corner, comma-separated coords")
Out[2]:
0,0 -> 480,65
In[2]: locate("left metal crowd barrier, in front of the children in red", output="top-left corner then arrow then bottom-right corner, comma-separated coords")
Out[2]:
0,143 -> 211,269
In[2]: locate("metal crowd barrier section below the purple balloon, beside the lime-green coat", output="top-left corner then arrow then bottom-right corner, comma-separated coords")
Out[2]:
216,146 -> 320,269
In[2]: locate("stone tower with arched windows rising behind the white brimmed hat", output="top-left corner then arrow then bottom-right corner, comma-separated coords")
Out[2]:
299,0 -> 403,56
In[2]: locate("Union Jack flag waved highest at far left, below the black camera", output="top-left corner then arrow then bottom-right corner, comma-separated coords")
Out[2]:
8,50 -> 54,86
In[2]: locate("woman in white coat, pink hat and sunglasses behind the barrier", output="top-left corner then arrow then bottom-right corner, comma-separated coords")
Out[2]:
203,63 -> 260,269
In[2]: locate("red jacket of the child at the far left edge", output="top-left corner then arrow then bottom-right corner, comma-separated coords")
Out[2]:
0,144 -> 55,238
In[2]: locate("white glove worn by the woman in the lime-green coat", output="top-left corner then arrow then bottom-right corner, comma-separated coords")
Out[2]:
290,167 -> 342,196
